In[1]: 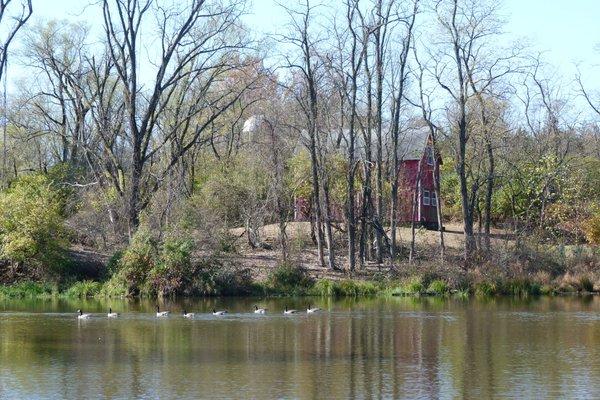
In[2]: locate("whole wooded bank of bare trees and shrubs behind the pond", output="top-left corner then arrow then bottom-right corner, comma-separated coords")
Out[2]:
0,0 -> 600,297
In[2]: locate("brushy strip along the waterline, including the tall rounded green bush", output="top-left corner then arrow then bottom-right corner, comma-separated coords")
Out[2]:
0,238 -> 600,298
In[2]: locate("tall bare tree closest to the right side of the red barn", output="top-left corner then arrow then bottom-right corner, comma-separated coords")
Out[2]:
433,0 -> 508,262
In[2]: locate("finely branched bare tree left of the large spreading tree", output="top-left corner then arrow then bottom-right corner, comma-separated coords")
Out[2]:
20,21 -> 95,165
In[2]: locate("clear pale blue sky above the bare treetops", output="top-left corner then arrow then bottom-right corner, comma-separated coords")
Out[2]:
10,0 -> 600,94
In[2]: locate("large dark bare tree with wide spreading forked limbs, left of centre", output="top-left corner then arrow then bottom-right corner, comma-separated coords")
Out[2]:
102,0 -> 251,235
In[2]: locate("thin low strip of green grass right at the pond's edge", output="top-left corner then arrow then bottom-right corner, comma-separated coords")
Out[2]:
0,276 -> 600,300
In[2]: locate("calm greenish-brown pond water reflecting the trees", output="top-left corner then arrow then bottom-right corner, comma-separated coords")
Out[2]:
0,297 -> 600,399
